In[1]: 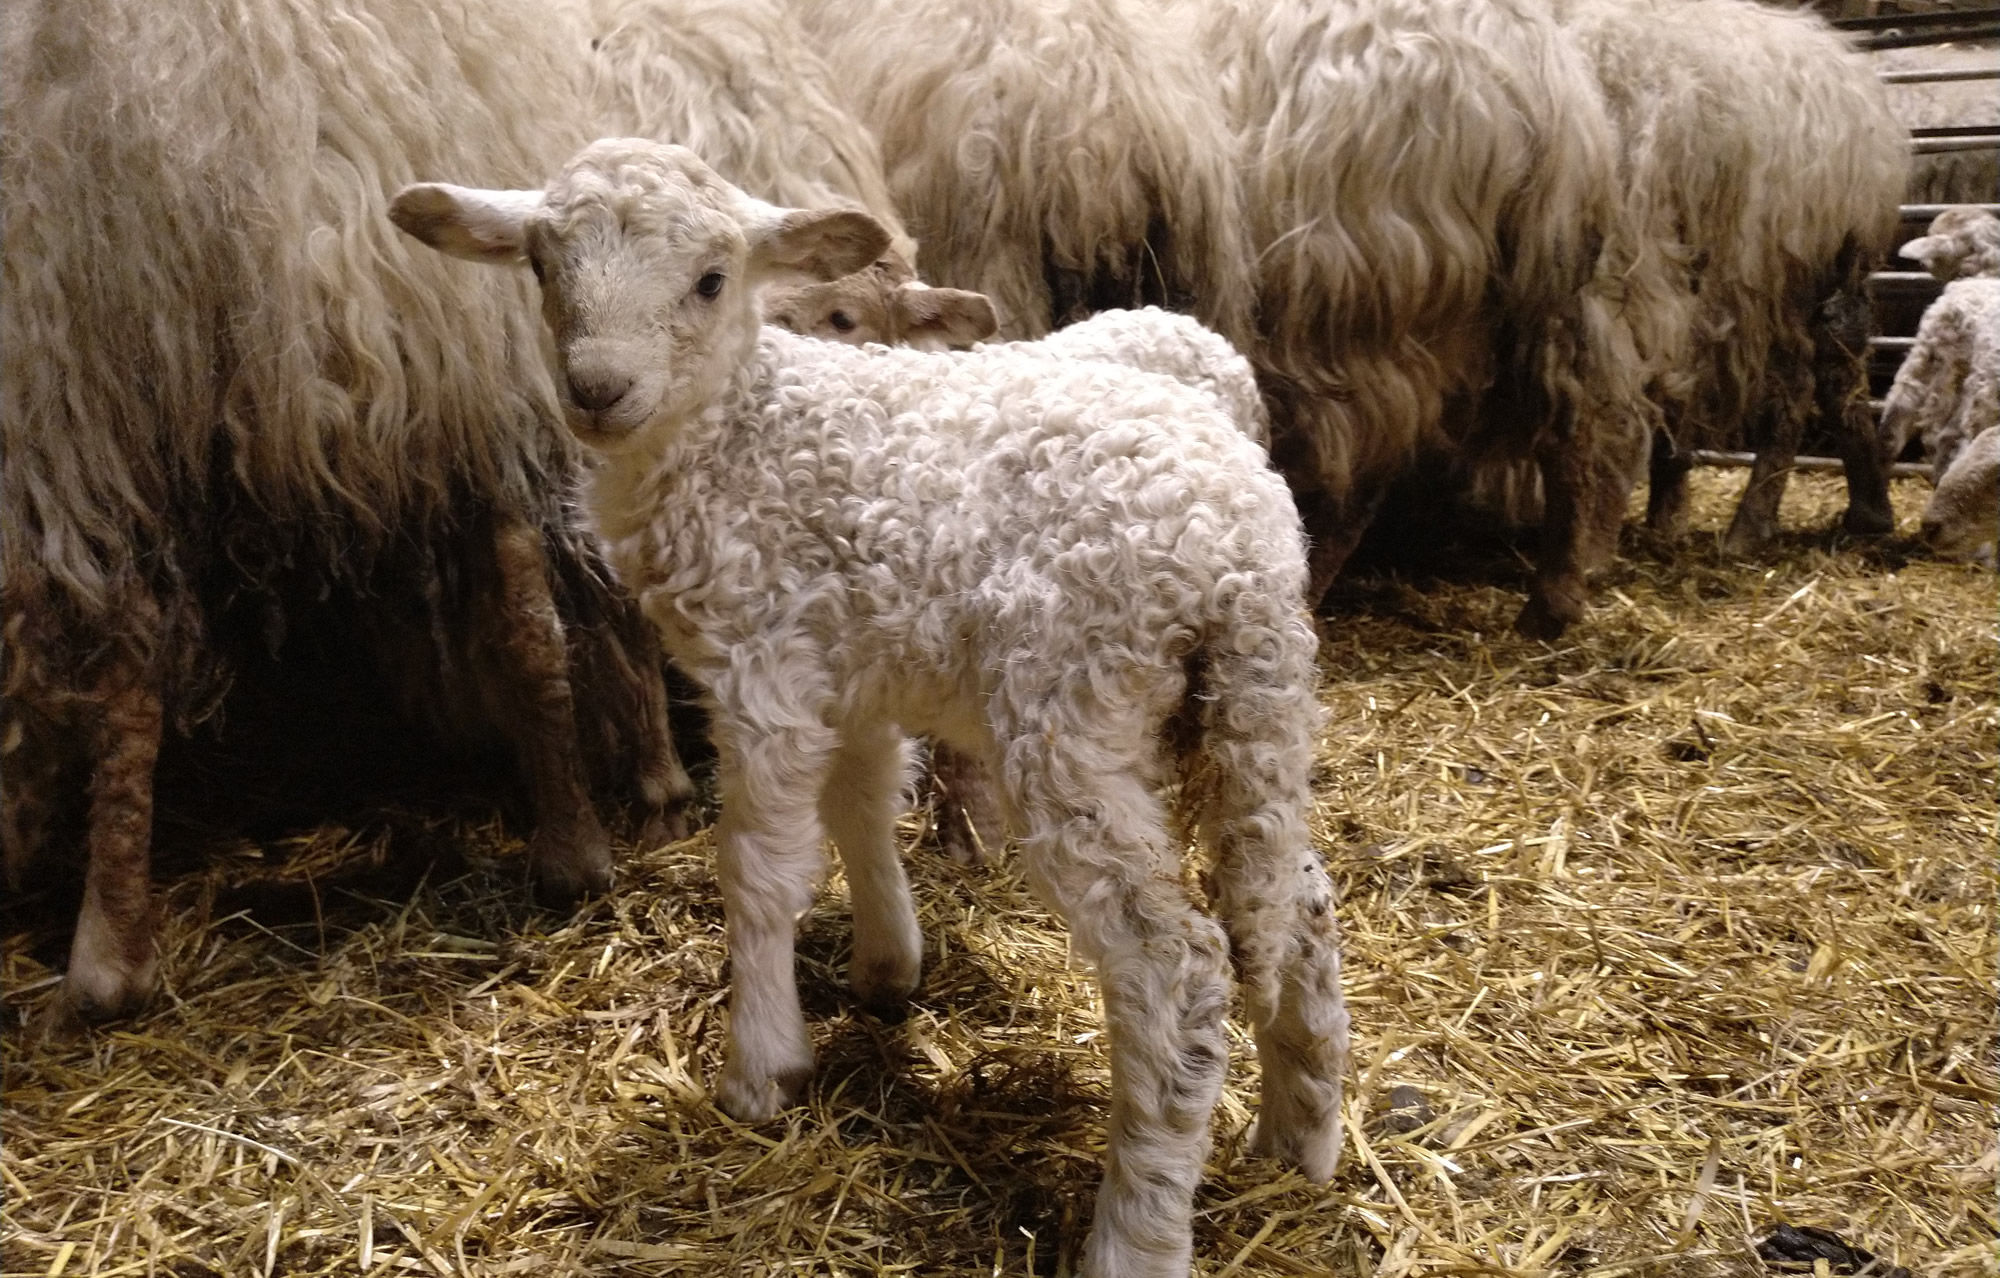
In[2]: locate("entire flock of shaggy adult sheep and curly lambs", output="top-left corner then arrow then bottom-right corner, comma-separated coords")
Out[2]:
0,0 -> 2000,1276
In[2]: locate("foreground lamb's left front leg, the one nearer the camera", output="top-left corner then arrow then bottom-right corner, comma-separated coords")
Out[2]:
716,724 -> 834,1122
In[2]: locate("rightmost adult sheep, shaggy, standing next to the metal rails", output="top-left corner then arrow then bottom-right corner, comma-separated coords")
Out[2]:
1558,0 -> 1908,552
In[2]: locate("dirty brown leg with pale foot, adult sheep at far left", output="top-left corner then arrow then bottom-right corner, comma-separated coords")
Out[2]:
62,620 -> 162,1020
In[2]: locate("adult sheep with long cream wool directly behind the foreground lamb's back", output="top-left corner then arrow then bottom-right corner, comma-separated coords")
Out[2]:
788,0 -> 1252,342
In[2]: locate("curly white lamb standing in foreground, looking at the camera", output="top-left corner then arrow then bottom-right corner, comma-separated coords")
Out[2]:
392,138 -> 1348,1278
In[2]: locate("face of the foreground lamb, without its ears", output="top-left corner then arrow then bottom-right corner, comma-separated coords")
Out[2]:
524,144 -> 758,446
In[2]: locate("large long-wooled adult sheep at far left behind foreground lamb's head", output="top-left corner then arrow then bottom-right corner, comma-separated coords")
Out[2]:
0,0 -> 908,1014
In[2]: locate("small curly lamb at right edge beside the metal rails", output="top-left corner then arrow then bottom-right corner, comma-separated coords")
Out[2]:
1882,208 -> 2000,496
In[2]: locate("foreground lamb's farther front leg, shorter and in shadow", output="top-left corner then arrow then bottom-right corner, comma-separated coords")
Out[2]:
820,724 -> 924,1012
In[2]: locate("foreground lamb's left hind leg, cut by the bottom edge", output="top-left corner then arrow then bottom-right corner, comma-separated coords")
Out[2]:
1008,728 -> 1228,1278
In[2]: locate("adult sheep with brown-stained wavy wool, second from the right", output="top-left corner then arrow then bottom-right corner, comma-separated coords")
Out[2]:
1174,0 -> 1664,636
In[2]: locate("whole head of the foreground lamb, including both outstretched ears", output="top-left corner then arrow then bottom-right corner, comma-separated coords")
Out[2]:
390,138 -> 888,448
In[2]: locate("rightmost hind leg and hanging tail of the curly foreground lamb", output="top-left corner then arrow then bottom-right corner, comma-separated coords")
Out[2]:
1184,590 -> 1348,1180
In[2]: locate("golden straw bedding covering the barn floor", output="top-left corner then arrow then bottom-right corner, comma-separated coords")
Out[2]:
0,472 -> 2000,1278
